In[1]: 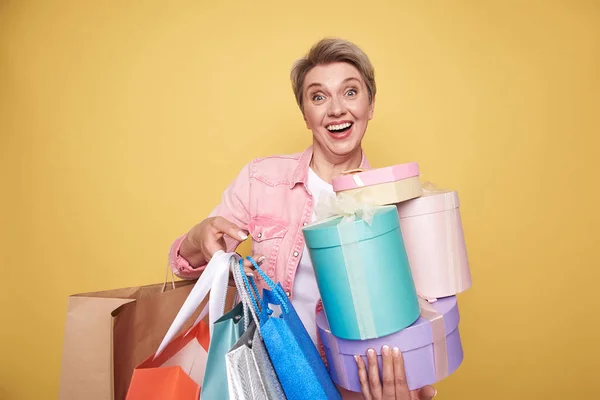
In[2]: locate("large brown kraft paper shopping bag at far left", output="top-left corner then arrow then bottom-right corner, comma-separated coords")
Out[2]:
59,281 -> 194,400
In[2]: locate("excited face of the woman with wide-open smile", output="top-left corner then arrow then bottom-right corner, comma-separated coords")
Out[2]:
303,62 -> 375,158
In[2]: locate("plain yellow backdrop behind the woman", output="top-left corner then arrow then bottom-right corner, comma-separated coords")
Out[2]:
0,0 -> 600,400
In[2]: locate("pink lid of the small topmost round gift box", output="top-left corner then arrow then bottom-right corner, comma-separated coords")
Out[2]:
331,162 -> 419,192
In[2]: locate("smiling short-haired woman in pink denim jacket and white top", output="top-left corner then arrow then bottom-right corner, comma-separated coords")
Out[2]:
169,39 -> 435,400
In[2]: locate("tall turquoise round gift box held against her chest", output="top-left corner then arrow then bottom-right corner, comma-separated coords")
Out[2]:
302,206 -> 420,340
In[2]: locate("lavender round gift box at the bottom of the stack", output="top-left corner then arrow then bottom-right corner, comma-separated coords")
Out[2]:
317,296 -> 463,392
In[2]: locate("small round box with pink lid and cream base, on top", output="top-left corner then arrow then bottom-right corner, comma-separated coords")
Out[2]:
331,163 -> 421,206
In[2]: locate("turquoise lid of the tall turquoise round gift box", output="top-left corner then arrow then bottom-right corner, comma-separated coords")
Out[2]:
302,206 -> 400,249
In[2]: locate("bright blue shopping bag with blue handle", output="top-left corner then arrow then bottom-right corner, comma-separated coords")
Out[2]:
246,257 -> 341,400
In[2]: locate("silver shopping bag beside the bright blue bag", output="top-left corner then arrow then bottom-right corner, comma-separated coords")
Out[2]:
226,259 -> 286,400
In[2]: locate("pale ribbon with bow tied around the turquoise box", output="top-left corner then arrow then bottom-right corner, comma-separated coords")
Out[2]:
314,193 -> 377,339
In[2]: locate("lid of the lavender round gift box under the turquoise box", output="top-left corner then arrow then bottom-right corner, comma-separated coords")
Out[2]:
317,296 -> 460,355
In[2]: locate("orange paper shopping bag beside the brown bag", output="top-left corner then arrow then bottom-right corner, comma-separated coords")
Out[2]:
126,320 -> 210,400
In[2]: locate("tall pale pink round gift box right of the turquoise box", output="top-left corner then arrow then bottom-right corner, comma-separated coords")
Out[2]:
397,189 -> 471,299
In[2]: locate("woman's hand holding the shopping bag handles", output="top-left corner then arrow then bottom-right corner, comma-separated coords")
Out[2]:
179,217 -> 264,278
